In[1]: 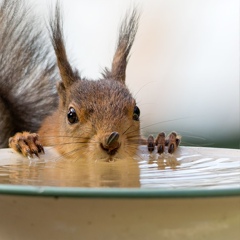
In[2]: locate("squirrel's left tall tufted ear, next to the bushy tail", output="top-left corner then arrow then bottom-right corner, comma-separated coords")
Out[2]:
50,2 -> 80,88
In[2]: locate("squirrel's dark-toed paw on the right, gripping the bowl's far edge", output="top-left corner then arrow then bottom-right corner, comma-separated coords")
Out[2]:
147,132 -> 181,154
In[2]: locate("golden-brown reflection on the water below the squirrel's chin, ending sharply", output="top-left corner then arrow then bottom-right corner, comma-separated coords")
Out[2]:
0,150 -> 139,187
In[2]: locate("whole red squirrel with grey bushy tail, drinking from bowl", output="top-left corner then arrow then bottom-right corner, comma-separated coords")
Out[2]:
0,0 -> 180,161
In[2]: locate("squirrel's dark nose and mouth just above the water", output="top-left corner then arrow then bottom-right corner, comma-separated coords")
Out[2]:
100,132 -> 120,155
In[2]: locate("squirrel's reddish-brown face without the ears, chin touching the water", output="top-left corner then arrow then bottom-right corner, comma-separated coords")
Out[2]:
52,79 -> 140,161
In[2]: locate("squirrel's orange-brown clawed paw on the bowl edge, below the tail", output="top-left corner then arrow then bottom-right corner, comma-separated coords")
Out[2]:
9,132 -> 44,158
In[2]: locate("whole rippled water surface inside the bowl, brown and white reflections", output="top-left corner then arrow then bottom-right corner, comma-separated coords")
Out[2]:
0,146 -> 240,189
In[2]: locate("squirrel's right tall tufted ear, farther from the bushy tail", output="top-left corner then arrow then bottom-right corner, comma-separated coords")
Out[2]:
103,9 -> 139,84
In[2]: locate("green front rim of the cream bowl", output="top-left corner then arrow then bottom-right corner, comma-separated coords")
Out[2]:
0,184 -> 240,198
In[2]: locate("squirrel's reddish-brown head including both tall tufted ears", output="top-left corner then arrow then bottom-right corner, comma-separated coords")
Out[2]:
46,6 -> 140,161
